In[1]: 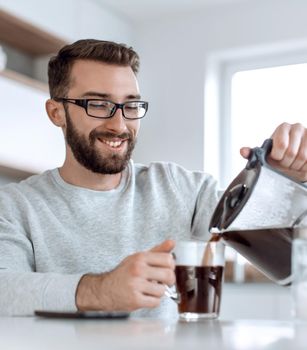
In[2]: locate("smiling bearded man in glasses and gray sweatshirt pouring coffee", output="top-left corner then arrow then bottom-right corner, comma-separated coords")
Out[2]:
0,40 -> 307,316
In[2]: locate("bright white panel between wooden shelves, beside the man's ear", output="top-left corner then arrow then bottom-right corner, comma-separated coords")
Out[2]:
0,77 -> 65,173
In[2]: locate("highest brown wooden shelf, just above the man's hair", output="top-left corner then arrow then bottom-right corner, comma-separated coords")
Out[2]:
0,10 -> 66,56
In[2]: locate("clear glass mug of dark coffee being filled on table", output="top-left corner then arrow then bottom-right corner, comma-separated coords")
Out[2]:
165,241 -> 225,321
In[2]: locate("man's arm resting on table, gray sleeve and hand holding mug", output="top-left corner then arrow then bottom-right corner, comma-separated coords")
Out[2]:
0,212 -> 175,316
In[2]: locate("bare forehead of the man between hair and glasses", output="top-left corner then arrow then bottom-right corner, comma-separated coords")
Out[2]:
69,60 -> 139,96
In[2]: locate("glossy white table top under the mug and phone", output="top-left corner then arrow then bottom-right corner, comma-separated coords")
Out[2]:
0,317 -> 307,350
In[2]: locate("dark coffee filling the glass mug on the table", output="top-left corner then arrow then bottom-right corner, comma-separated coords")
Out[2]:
175,265 -> 224,315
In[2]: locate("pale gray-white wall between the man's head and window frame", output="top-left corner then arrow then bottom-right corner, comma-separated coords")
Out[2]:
135,0 -> 307,174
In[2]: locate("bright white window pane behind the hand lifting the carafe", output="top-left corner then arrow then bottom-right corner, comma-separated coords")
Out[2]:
229,63 -> 307,183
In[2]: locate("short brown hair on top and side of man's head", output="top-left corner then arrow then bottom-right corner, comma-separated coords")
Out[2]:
48,39 -> 140,98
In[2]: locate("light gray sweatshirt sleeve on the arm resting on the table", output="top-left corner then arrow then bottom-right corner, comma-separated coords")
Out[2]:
0,187 -> 82,316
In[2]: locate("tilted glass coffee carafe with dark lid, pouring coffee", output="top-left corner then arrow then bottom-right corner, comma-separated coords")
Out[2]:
210,139 -> 307,285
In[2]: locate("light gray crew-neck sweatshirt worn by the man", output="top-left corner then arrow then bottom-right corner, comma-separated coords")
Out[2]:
0,161 -> 217,317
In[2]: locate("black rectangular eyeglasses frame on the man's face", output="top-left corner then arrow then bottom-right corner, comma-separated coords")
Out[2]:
53,97 -> 148,120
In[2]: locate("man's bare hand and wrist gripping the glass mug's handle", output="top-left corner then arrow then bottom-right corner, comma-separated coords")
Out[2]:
76,240 -> 175,311
